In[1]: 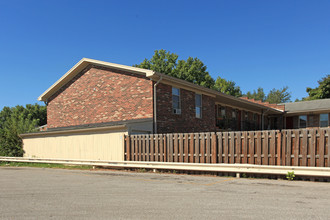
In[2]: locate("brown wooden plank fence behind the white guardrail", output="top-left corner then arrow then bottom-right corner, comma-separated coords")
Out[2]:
124,128 -> 330,167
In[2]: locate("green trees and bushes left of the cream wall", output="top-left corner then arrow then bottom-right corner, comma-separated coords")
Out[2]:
0,104 -> 47,156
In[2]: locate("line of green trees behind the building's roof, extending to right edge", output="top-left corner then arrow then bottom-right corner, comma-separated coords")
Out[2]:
134,49 -> 330,103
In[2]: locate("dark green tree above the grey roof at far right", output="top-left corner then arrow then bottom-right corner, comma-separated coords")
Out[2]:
303,74 -> 330,100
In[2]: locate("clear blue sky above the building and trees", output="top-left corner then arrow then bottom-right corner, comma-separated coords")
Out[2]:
0,0 -> 330,109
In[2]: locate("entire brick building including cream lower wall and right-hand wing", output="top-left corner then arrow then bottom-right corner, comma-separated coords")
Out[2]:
21,58 -> 330,161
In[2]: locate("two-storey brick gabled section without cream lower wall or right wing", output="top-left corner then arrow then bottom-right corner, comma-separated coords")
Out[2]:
39,58 -> 284,133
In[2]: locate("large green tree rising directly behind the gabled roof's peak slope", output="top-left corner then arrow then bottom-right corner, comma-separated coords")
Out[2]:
134,49 -> 214,88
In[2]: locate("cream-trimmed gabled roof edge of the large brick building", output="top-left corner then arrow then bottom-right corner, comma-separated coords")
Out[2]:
38,58 -> 283,114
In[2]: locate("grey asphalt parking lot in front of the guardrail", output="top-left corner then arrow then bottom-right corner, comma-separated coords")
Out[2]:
0,167 -> 330,219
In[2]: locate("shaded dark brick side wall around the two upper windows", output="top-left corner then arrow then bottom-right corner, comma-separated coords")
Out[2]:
157,83 -> 216,133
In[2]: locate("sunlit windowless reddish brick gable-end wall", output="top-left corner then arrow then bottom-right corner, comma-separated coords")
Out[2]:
47,66 -> 153,128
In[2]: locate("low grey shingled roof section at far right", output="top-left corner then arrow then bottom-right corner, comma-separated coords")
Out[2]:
284,99 -> 330,113
